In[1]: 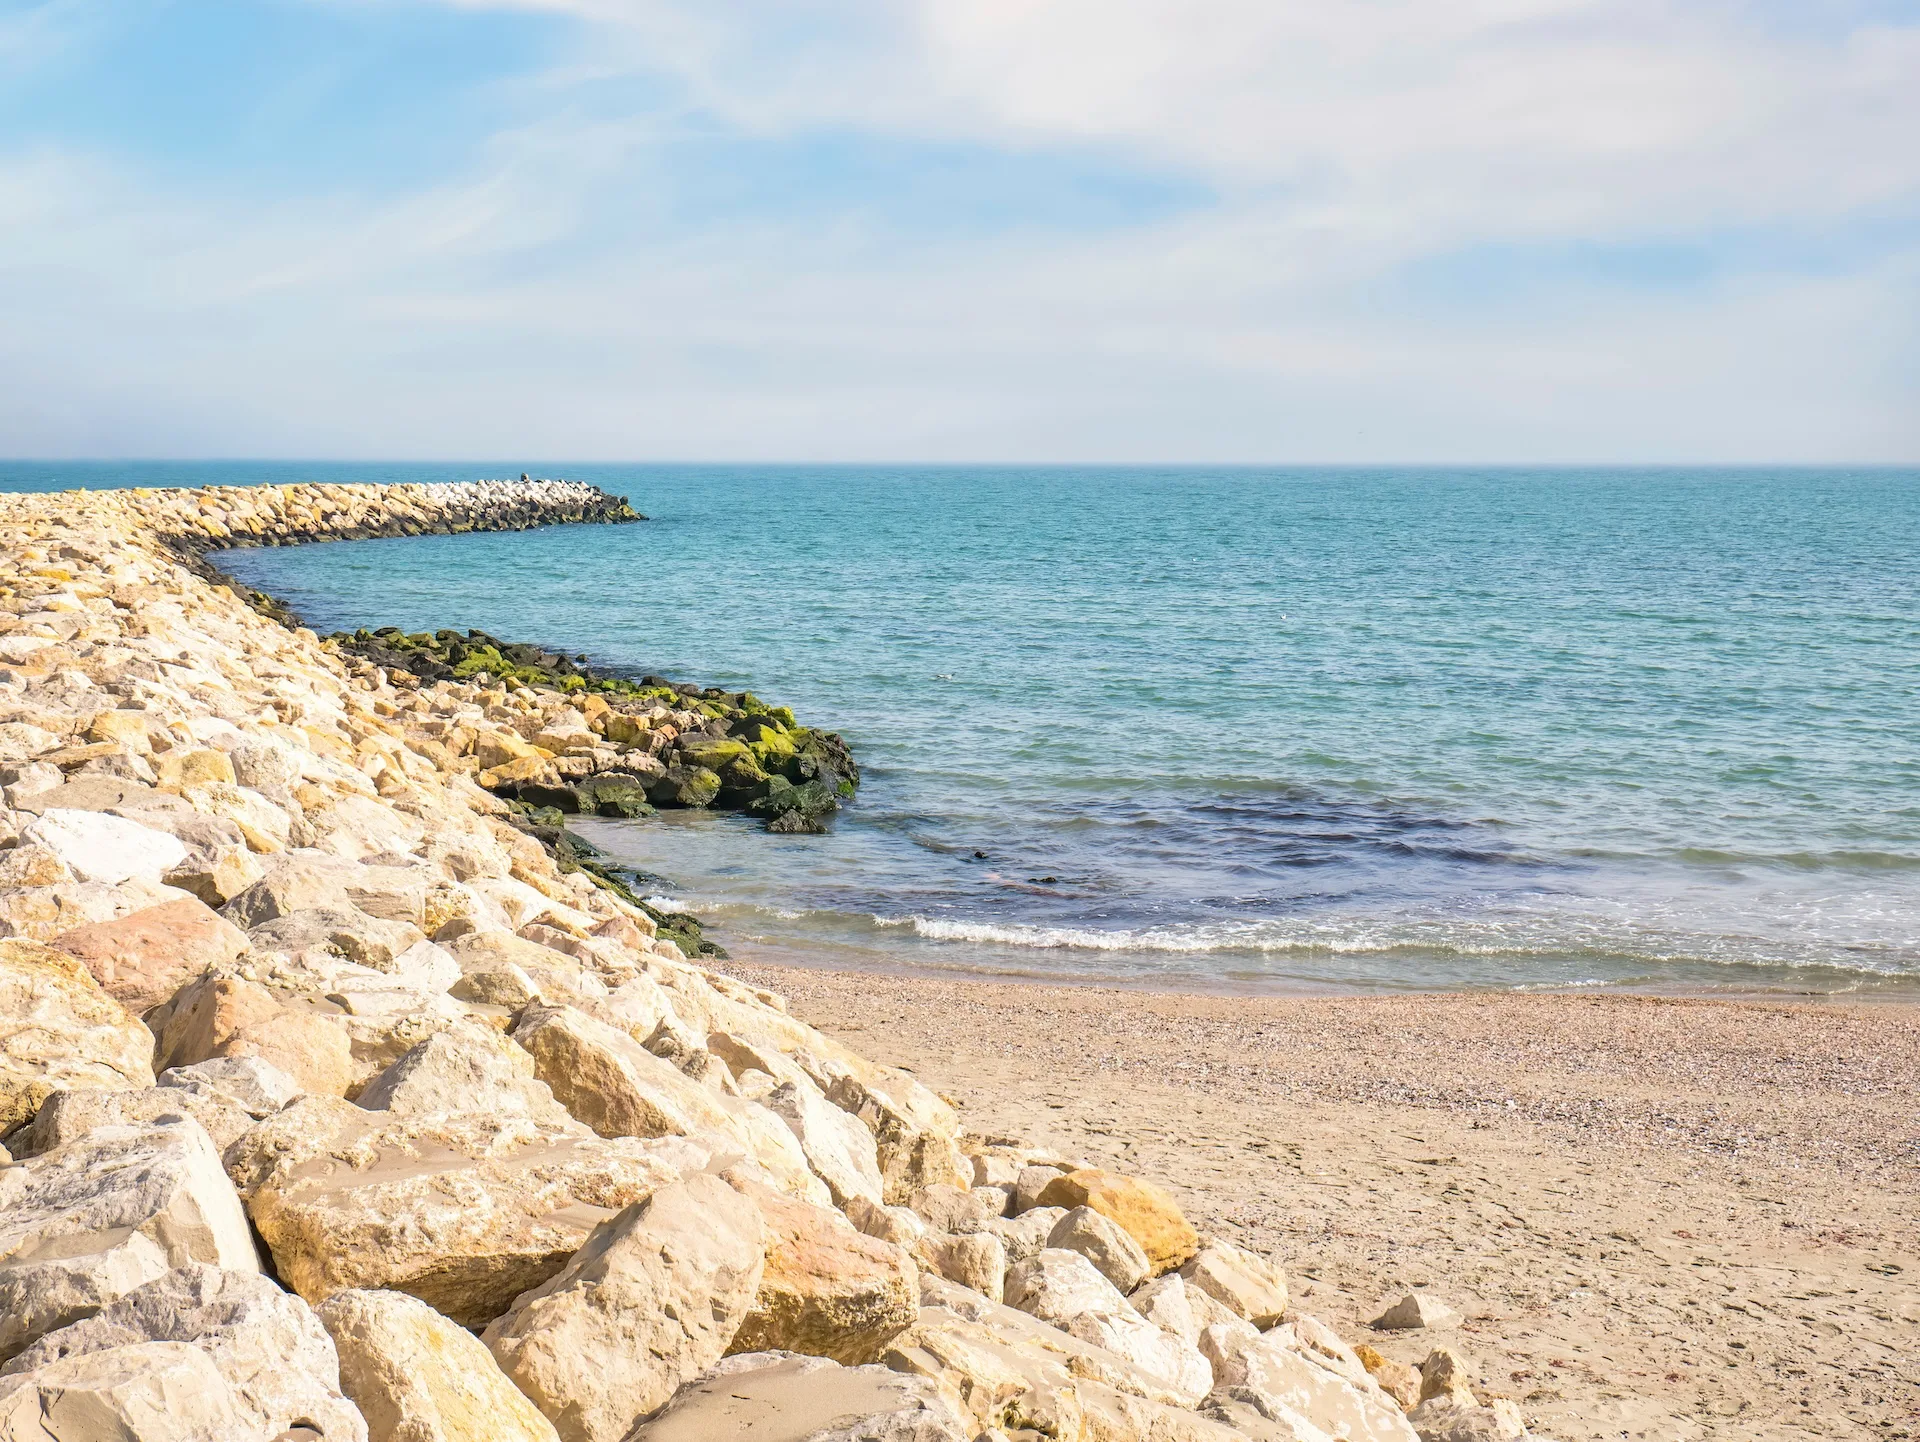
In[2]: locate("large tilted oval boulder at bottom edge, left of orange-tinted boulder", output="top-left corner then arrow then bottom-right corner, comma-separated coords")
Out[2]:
486,1175 -> 762,1442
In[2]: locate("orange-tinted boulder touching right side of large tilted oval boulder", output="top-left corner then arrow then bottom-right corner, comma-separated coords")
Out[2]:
730,1173 -> 920,1363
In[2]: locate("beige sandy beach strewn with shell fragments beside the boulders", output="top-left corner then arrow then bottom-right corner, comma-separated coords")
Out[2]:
728,962 -> 1920,1442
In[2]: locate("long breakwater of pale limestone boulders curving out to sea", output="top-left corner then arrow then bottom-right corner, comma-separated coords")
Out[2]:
0,482 -> 1526,1442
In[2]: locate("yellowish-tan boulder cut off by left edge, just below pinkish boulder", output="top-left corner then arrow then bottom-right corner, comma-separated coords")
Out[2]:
0,941 -> 154,1133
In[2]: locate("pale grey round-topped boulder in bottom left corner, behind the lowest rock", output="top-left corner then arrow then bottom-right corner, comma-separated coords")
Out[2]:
0,1265 -> 367,1442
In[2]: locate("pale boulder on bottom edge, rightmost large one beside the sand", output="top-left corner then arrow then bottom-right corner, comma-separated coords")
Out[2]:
1200,1327 -> 1419,1442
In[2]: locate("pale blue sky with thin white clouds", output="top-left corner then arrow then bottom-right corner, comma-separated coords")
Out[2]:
0,0 -> 1920,463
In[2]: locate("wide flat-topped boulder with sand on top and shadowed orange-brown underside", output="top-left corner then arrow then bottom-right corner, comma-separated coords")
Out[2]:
227,1096 -> 712,1327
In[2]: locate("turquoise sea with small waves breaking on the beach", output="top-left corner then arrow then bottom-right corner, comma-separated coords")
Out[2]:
0,463 -> 1920,993
